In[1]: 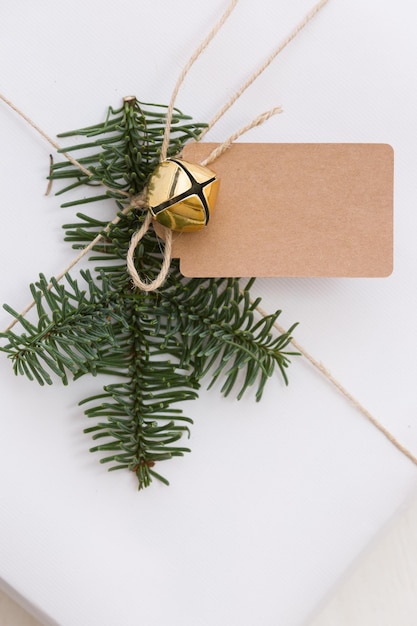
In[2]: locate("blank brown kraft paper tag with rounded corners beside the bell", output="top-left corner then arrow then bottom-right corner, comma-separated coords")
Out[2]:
173,143 -> 393,277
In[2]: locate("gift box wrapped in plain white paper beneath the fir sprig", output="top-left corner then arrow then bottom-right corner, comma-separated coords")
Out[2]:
0,0 -> 417,626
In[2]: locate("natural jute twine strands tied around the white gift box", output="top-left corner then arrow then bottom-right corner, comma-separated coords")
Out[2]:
0,0 -> 417,465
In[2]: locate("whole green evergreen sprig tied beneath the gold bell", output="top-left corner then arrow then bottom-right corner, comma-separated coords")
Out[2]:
0,98 -> 295,489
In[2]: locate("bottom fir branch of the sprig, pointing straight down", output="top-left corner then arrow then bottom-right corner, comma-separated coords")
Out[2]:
83,303 -> 198,489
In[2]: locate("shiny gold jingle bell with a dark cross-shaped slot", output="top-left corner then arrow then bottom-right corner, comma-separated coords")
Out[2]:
146,159 -> 219,232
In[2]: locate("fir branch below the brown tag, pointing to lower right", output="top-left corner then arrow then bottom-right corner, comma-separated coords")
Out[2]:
158,278 -> 296,401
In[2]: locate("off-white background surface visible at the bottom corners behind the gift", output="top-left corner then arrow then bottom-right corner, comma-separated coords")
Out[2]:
0,492 -> 417,626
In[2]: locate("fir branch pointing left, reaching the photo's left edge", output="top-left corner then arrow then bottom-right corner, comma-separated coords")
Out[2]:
0,272 -> 124,385
